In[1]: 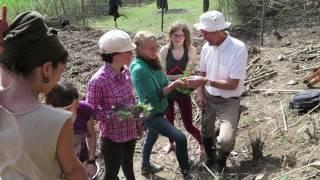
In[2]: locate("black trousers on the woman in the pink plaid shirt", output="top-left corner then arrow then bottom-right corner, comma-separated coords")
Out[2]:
101,137 -> 136,180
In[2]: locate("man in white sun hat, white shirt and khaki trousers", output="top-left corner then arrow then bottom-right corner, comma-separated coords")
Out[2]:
188,11 -> 248,172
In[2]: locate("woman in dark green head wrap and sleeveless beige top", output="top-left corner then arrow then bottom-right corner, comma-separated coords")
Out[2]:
0,11 -> 87,180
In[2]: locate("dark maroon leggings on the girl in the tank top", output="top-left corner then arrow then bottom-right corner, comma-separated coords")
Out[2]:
166,96 -> 201,144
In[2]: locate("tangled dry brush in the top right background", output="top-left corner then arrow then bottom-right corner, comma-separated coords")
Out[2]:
235,0 -> 320,28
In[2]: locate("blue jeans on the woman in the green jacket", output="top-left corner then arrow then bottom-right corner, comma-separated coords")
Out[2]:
142,115 -> 189,171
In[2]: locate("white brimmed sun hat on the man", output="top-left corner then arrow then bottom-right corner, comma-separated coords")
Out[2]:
193,11 -> 231,32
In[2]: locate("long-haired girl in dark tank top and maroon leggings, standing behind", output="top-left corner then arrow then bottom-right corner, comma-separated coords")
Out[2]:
160,21 -> 204,154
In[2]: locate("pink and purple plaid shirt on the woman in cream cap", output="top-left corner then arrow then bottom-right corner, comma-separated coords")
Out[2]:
87,63 -> 142,142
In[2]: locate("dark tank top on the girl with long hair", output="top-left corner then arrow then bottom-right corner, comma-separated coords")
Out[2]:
166,48 -> 189,99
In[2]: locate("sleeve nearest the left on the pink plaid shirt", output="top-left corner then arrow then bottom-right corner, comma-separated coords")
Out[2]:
87,79 -> 105,121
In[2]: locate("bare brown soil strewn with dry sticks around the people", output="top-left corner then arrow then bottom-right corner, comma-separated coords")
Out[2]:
60,24 -> 320,180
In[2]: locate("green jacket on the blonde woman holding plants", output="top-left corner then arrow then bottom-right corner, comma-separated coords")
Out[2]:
130,58 -> 169,116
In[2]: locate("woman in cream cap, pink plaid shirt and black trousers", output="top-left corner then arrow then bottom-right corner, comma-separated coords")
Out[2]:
87,30 -> 143,180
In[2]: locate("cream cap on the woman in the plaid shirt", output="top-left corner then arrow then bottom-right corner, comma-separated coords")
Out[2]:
98,30 -> 137,54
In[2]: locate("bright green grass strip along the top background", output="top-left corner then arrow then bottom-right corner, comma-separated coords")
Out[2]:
0,0 -> 233,34
